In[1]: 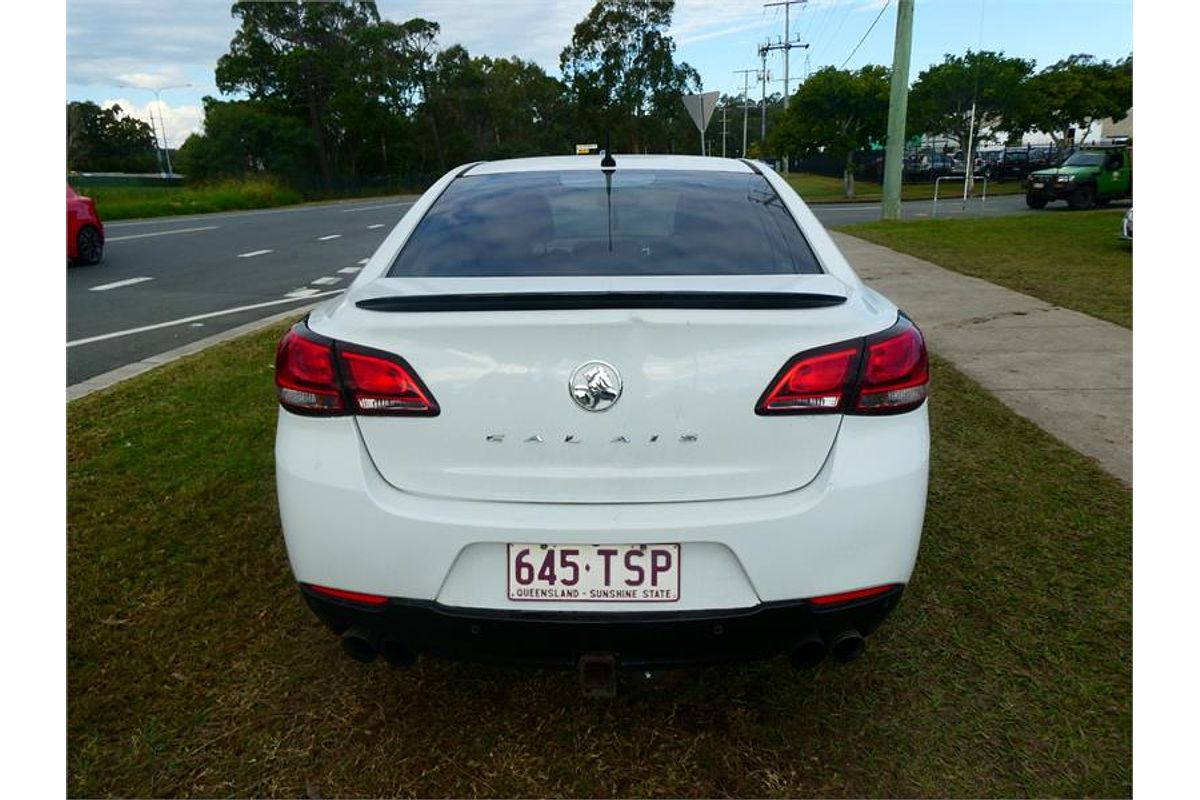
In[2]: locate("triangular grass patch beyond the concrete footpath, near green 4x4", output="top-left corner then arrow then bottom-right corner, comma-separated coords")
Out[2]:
838,209 -> 1133,327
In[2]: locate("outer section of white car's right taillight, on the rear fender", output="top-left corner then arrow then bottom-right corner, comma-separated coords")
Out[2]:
854,317 -> 929,414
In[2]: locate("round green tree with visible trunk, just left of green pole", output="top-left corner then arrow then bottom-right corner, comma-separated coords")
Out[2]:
770,65 -> 890,197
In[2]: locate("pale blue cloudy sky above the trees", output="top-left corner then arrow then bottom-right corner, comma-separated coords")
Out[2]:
66,0 -> 1133,146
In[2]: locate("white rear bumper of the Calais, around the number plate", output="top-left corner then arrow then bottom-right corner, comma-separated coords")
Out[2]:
276,404 -> 929,614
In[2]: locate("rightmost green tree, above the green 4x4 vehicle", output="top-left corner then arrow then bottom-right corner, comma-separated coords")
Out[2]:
1021,53 -> 1133,144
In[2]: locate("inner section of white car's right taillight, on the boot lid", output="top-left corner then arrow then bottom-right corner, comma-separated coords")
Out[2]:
755,344 -> 859,414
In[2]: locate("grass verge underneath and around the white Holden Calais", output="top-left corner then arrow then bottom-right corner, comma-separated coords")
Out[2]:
67,326 -> 1133,796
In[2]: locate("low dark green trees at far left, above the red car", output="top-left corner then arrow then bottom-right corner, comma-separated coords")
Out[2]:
67,101 -> 158,173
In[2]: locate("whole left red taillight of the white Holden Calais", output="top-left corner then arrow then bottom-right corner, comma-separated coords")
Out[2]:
275,323 -> 439,416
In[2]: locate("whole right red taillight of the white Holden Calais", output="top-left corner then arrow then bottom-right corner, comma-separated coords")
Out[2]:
755,315 -> 929,415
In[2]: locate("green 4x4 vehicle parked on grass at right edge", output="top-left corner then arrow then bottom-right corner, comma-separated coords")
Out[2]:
1025,145 -> 1133,209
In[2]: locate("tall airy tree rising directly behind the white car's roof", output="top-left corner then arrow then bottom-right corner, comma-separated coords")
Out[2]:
559,0 -> 700,152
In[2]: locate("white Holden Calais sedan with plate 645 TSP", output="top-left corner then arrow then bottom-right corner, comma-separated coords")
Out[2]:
275,149 -> 929,685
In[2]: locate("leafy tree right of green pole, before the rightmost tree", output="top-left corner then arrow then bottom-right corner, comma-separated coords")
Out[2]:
908,50 -> 1033,155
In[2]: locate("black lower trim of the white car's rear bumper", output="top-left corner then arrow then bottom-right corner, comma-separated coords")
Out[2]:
301,585 -> 904,668
